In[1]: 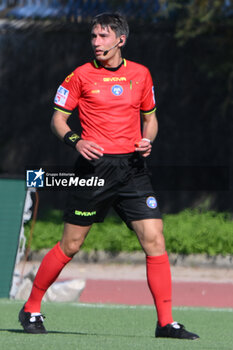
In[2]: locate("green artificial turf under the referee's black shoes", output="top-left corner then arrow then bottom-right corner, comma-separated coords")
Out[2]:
0,299 -> 233,350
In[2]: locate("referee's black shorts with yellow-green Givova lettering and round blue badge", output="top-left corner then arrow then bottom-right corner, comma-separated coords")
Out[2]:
64,153 -> 161,228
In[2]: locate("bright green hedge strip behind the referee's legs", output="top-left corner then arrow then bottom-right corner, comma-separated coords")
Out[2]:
25,209 -> 233,256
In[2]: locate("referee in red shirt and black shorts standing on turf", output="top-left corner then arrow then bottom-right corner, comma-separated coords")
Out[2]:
19,13 -> 199,339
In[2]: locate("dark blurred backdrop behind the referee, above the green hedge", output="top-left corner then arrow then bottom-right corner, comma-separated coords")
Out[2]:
0,0 -> 233,213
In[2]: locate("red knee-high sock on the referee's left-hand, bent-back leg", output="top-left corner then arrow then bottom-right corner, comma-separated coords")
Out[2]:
24,242 -> 71,313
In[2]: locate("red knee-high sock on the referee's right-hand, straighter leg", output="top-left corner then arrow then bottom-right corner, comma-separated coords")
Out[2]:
146,253 -> 173,327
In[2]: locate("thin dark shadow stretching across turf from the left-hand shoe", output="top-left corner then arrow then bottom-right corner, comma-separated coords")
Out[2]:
0,328 -> 148,338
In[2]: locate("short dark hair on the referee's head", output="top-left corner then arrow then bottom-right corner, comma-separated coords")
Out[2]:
91,12 -> 129,39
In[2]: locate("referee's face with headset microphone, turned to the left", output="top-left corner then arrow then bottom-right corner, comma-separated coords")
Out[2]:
91,24 -> 120,61
